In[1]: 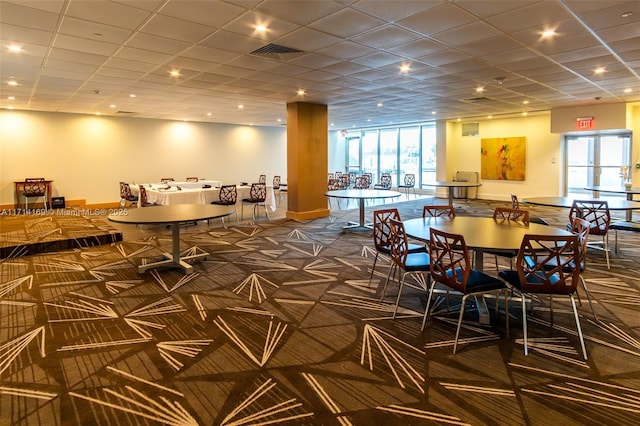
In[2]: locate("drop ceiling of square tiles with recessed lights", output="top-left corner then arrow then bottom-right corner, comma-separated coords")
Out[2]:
0,0 -> 640,129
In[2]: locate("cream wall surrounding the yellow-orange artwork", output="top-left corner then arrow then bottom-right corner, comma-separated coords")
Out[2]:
438,113 -> 563,200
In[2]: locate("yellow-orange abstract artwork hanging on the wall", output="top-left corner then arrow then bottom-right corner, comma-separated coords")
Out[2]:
480,137 -> 527,180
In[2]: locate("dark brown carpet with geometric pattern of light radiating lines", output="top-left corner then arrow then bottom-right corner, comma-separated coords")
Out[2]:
0,200 -> 640,426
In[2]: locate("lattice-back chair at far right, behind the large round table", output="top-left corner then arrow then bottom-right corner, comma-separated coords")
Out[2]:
569,200 -> 611,269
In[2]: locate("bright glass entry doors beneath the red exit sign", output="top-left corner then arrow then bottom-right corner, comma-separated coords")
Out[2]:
565,134 -> 631,197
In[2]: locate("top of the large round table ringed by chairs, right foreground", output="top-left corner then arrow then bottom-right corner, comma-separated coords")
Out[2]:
404,216 -> 571,250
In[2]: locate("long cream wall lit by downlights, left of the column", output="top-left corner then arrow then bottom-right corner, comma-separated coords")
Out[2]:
0,111 -> 287,205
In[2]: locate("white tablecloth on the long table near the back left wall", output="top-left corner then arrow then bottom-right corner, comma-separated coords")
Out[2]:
144,185 -> 276,211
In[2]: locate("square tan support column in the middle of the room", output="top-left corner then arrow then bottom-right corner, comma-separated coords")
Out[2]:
287,102 -> 329,220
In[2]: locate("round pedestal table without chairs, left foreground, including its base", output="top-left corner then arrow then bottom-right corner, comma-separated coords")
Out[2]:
108,204 -> 234,274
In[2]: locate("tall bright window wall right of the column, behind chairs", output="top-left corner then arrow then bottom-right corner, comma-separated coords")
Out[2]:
346,124 -> 436,188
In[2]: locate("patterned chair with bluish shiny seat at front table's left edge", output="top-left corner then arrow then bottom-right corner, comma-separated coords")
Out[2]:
387,218 -> 431,318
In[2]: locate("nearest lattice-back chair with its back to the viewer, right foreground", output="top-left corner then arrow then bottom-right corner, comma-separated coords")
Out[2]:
498,234 -> 587,360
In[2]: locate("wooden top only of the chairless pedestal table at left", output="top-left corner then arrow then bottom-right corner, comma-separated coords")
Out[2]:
109,204 -> 234,224
